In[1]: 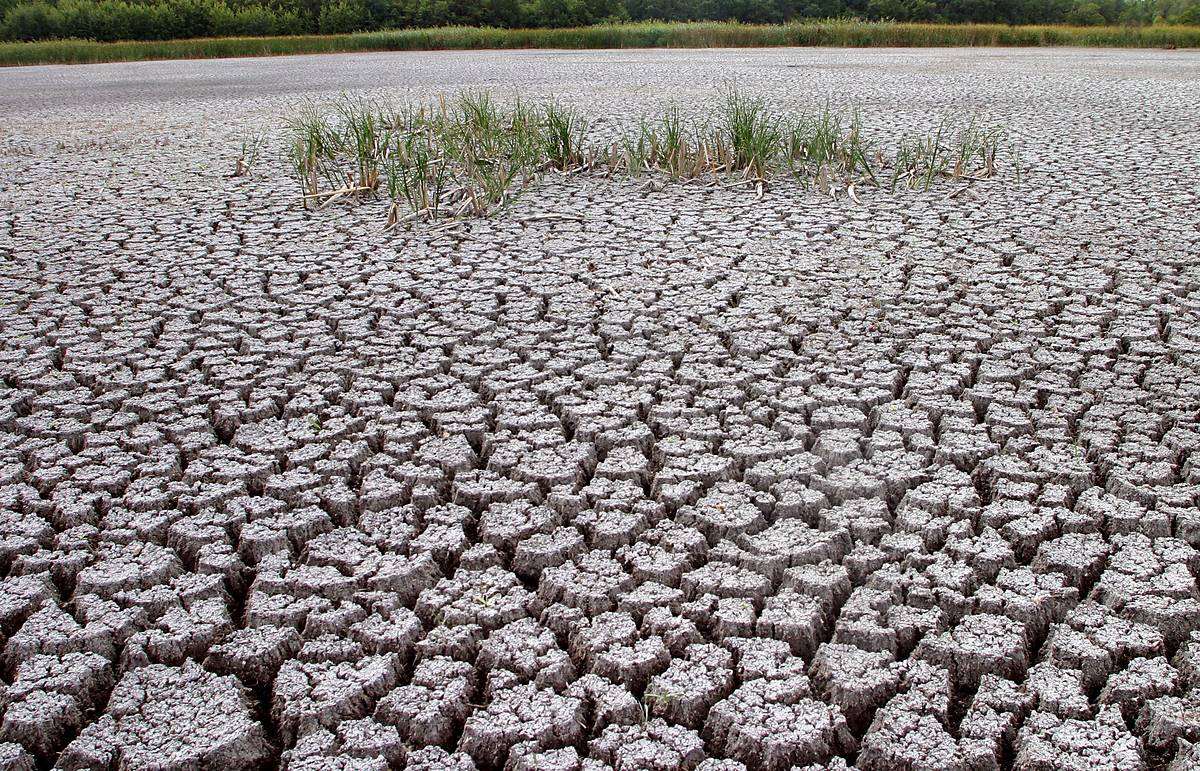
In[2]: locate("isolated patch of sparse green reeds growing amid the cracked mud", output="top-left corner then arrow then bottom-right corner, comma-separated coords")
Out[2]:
285,89 -> 1003,229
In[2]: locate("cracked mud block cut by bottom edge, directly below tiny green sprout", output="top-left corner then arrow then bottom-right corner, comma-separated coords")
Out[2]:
588,718 -> 704,771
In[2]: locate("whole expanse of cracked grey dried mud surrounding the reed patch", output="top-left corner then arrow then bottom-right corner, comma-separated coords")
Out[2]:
0,50 -> 1200,771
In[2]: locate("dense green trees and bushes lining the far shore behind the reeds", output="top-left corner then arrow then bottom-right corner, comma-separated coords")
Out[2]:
7,0 -> 1200,41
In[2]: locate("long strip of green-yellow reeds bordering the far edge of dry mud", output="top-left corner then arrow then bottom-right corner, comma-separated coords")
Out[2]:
0,22 -> 1200,66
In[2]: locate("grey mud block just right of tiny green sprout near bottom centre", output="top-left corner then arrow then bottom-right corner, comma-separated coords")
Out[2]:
642,643 -> 733,729
